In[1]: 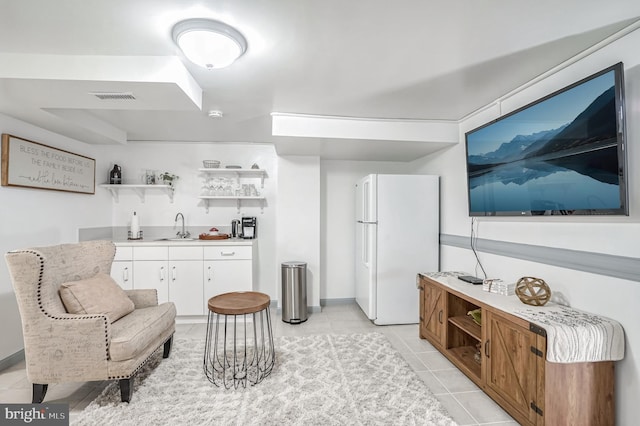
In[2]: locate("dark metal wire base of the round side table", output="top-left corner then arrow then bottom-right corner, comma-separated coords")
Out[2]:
203,308 -> 275,389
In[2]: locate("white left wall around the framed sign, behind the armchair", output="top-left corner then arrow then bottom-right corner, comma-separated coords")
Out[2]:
0,115 -> 111,360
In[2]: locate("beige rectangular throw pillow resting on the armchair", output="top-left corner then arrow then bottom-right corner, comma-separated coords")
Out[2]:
60,274 -> 135,323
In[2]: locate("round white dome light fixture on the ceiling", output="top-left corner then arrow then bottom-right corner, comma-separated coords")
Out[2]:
172,19 -> 247,70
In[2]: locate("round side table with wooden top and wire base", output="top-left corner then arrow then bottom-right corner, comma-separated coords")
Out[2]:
203,291 -> 275,389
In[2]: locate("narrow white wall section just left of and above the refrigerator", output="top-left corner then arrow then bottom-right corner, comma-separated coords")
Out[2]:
320,160 -> 407,299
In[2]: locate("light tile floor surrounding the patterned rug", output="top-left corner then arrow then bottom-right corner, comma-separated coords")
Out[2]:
0,304 -> 518,426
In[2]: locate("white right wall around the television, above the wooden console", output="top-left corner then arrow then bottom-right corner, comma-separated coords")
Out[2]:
412,31 -> 640,425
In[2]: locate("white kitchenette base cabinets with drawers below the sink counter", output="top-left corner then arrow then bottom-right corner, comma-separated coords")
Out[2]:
111,243 -> 254,316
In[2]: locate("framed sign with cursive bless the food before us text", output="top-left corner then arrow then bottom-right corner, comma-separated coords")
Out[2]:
2,133 -> 96,194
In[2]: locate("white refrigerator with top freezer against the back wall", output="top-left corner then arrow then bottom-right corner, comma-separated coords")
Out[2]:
355,174 -> 440,325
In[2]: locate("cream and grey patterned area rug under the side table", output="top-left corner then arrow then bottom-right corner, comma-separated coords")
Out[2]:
71,333 -> 455,426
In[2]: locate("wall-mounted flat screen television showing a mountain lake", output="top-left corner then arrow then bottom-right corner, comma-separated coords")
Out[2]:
465,63 -> 629,216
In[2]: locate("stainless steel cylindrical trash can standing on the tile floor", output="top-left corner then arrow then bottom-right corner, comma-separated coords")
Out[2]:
282,262 -> 307,324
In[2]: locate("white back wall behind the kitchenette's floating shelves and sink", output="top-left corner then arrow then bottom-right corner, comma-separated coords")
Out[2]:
97,142 -> 278,299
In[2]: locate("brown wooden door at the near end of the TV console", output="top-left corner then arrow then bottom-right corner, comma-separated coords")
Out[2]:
482,310 -> 538,424
